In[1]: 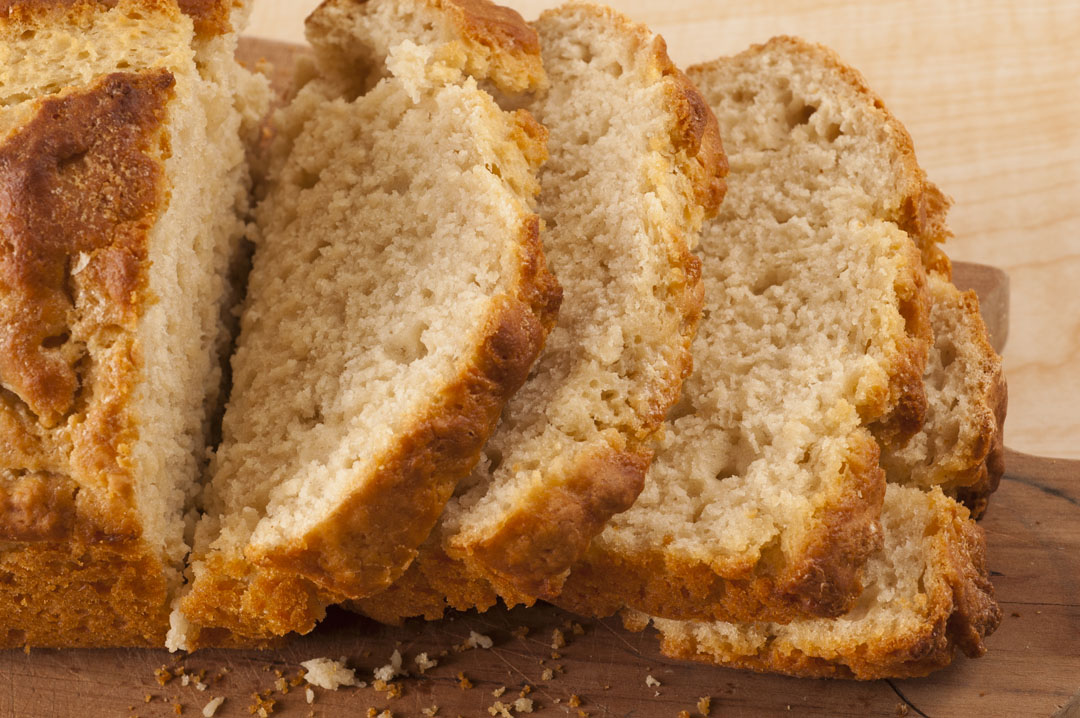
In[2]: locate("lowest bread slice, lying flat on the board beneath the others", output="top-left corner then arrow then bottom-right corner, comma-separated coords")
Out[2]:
639,484 -> 1001,680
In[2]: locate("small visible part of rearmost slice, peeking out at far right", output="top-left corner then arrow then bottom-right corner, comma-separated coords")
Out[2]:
881,272 -> 1008,517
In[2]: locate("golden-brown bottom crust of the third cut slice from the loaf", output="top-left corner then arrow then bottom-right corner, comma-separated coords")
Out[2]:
551,433 -> 885,623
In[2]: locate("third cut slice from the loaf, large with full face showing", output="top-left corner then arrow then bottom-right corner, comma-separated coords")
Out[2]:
548,38 -> 937,621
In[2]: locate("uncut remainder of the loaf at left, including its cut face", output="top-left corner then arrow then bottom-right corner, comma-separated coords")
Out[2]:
0,0 -> 268,647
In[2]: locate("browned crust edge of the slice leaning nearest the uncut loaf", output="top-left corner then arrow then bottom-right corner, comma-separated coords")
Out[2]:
183,210 -> 562,648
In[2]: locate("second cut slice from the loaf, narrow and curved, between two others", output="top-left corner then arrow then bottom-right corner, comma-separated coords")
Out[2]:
429,3 -> 727,596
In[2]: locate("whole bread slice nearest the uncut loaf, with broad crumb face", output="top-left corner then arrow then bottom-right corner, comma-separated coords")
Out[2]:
170,0 -> 559,648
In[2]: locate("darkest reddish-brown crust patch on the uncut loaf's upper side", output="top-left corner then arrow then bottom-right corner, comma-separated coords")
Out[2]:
0,70 -> 174,428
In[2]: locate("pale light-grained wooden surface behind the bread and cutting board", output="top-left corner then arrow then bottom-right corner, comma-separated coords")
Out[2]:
248,0 -> 1080,458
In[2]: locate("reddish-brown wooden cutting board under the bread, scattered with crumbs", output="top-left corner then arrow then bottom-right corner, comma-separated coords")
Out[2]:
0,41 -> 1080,718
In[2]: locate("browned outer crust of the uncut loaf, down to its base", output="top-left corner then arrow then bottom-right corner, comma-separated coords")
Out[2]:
0,70 -> 174,647
